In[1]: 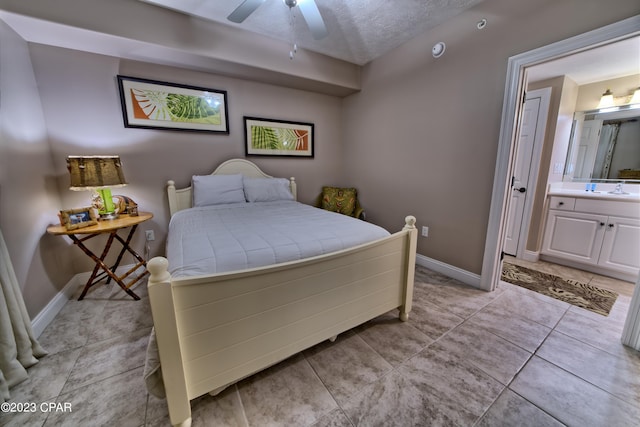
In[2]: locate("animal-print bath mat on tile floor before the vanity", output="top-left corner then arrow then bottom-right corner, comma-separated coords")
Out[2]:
501,262 -> 618,316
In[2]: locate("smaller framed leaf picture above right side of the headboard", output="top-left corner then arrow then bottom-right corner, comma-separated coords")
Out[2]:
244,117 -> 313,157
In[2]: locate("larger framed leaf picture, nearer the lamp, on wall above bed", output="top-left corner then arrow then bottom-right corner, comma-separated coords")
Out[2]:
118,76 -> 229,134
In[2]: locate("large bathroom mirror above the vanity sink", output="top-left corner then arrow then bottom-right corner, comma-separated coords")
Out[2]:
563,108 -> 640,184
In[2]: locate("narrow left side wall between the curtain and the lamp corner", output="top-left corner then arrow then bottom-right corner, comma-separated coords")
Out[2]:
0,21 -> 74,317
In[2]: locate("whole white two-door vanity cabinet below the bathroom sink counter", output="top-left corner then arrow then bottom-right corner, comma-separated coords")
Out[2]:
541,196 -> 640,281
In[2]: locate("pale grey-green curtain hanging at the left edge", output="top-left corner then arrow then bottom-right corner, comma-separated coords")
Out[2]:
0,226 -> 47,402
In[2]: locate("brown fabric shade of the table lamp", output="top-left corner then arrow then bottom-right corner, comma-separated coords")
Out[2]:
67,156 -> 127,190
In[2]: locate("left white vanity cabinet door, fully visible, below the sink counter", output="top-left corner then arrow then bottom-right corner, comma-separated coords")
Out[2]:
542,210 -> 607,265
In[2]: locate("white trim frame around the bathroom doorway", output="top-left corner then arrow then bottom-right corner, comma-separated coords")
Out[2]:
480,16 -> 640,349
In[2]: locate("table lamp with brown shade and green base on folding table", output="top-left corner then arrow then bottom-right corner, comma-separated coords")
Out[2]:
67,156 -> 127,219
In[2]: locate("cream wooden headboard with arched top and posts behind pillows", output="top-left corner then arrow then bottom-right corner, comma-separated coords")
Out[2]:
167,159 -> 298,216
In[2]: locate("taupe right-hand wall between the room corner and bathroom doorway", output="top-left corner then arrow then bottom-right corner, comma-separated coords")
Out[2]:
344,0 -> 640,274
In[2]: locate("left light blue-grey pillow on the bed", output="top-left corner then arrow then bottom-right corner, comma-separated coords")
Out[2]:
191,174 -> 245,207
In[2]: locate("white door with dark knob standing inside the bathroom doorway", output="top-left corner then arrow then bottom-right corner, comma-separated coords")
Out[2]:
503,91 -> 547,256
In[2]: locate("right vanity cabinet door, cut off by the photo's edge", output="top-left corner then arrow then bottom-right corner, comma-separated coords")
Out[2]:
598,216 -> 640,275
